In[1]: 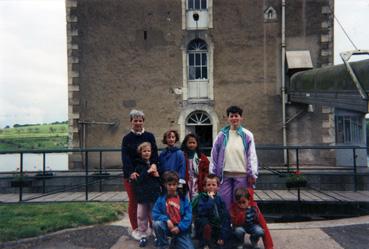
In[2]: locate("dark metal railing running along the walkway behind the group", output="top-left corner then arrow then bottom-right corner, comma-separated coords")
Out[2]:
0,145 -> 368,202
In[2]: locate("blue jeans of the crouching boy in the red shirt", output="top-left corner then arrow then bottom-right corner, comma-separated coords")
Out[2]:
153,221 -> 194,249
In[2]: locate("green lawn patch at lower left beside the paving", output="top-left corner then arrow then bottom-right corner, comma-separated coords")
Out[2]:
0,203 -> 126,242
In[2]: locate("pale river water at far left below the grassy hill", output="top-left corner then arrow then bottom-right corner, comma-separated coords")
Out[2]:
0,153 -> 68,172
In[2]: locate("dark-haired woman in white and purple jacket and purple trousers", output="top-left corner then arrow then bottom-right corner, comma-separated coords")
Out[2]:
209,106 -> 258,210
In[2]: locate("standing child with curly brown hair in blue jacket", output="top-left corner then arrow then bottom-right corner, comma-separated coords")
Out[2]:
159,130 -> 186,188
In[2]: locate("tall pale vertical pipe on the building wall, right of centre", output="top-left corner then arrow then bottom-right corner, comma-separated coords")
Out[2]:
281,0 -> 287,164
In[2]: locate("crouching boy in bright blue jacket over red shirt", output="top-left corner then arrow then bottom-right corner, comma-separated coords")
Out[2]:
152,171 -> 194,249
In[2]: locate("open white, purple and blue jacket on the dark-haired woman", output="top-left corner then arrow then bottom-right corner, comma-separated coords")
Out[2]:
209,126 -> 258,181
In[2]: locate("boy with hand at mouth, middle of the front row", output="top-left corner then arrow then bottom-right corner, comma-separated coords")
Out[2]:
192,174 -> 230,248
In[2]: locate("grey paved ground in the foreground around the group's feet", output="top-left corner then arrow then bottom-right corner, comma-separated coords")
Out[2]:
0,216 -> 369,249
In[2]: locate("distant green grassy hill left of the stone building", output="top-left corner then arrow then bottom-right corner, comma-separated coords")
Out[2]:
0,122 -> 68,150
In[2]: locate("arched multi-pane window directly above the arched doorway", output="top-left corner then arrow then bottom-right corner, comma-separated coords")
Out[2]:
187,39 -> 208,80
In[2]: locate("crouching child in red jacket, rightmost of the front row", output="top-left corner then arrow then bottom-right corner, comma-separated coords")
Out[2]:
231,188 -> 273,249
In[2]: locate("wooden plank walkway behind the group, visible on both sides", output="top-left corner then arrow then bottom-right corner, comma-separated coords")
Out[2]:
0,190 -> 369,203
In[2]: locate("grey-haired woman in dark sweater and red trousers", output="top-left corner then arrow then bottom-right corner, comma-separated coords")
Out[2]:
122,110 -> 158,240
